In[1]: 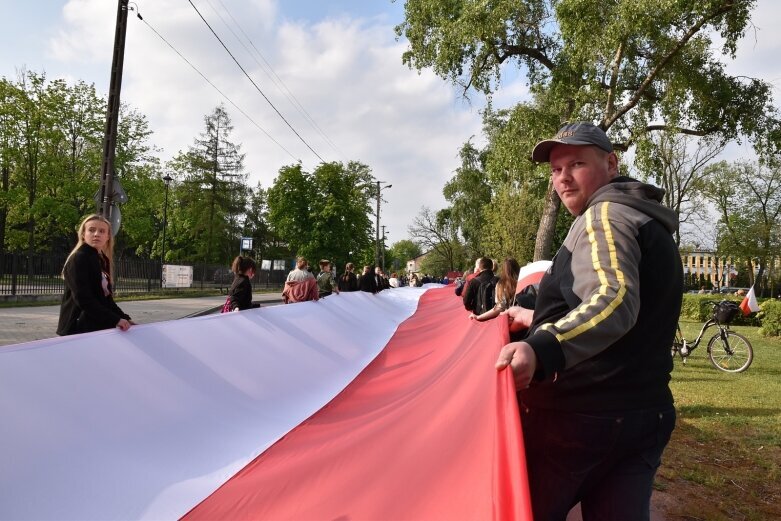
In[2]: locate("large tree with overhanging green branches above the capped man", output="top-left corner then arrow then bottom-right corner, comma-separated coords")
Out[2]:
396,0 -> 778,259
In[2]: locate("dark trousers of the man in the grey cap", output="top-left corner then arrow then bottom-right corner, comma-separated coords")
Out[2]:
519,403 -> 675,521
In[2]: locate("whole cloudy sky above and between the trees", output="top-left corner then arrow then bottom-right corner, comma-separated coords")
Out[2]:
0,0 -> 781,243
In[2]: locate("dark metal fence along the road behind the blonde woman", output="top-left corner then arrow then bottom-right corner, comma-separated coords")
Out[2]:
0,253 -> 287,296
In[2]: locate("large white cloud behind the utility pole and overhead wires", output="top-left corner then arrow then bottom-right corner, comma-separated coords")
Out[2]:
38,0 -> 480,241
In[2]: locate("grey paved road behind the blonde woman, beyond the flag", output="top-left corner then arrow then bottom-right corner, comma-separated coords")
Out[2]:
0,293 -> 281,346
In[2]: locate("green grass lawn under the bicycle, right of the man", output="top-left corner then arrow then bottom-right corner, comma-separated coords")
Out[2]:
656,320 -> 781,520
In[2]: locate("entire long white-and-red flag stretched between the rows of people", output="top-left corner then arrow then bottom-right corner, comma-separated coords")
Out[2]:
0,282 -> 531,520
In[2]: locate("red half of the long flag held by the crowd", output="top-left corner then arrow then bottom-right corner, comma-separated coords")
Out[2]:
185,288 -> 531,520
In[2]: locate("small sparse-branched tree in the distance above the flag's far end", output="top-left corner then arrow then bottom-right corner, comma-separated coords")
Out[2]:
408,206 -> 467,272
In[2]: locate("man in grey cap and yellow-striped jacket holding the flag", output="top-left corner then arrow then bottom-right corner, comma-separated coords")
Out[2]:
496,122 -> 683,521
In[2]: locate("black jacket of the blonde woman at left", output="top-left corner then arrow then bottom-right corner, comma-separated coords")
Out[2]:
57,244 -> 130,335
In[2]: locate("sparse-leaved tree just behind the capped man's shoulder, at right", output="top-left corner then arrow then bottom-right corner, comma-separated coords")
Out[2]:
635,132 -> 724,246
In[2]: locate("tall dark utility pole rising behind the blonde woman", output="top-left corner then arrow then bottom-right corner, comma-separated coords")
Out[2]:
98,0 -> 128,221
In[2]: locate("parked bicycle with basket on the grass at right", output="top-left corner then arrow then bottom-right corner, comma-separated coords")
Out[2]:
671,300 -> 754,373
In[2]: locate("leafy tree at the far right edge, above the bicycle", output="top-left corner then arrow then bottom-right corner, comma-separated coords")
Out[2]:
705,161 -> 781,296
